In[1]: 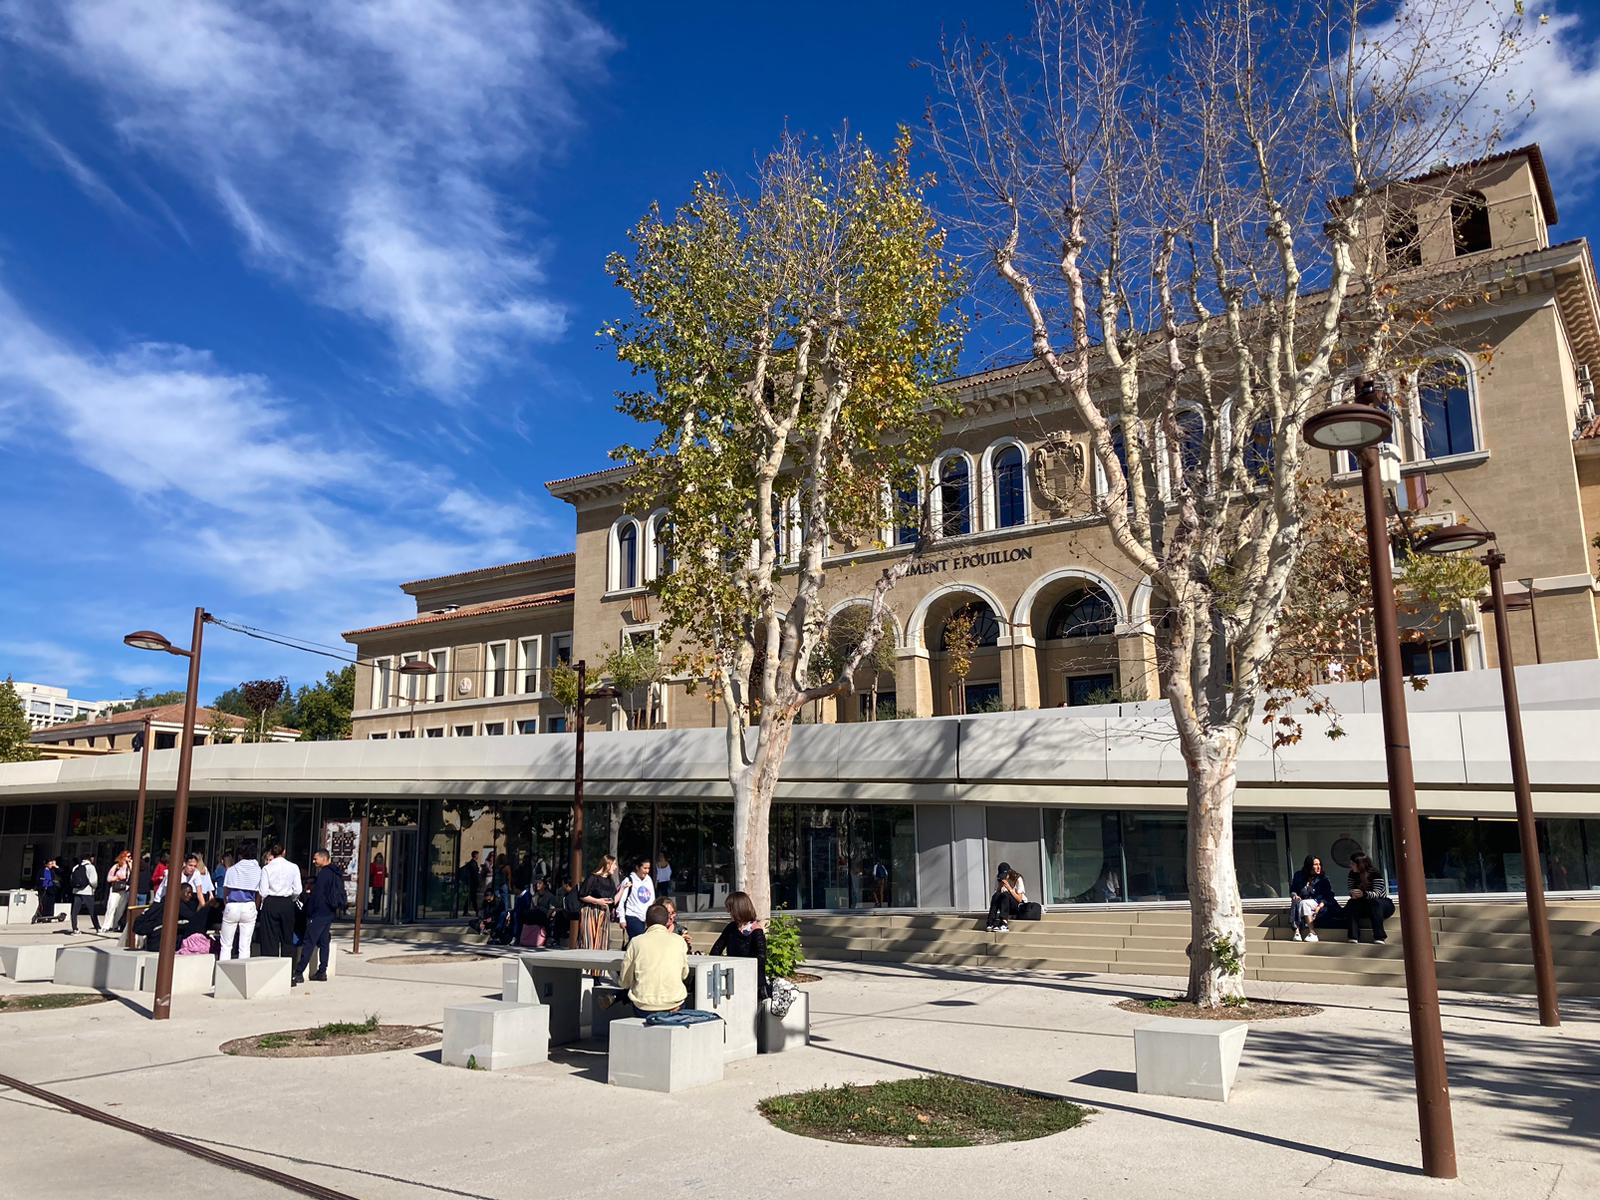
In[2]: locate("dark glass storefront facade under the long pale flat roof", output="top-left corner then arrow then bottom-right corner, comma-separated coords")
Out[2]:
0,797 -> 1600,922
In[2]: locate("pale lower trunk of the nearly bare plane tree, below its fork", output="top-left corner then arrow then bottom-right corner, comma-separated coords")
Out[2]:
1187,746 -> 1245,1008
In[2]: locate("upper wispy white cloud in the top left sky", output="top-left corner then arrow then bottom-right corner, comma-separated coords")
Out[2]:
0,0 -> 610,397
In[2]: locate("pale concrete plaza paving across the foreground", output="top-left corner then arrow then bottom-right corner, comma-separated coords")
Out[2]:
0,934 -> 1600,1200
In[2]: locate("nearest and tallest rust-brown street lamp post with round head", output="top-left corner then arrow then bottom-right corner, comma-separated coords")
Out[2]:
1304,387 -> 1456,1179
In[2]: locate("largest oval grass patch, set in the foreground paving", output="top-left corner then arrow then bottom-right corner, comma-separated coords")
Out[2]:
757,1075 -> 1091,1146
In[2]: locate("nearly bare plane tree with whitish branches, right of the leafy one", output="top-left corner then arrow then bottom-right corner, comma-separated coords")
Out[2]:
930,0 -> 1520,1005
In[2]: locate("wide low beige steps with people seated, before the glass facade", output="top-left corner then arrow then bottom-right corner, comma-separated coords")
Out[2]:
685,899 -> 1600,995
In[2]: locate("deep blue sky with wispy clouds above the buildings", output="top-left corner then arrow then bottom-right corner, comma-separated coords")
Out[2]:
0,0 -> 1600,698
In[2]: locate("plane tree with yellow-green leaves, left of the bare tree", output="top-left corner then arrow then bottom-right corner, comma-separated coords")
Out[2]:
605,131 -> 962,914
